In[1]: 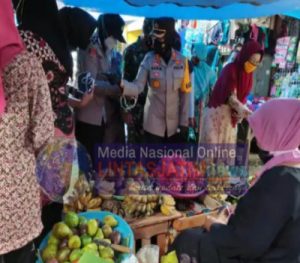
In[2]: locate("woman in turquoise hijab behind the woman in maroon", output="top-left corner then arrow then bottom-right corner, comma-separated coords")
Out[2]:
191,43 -> 217,138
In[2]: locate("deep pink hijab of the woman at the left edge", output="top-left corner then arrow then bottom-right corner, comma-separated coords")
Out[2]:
0,0 -> 24,116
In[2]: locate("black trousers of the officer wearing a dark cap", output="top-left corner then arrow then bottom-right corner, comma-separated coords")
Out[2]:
75,121 -> 105,163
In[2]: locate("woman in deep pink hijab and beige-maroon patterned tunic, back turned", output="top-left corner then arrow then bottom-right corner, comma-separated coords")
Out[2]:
0,0 -> 54,263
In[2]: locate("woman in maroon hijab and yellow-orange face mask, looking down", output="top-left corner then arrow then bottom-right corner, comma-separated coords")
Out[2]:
200,41 -> 263,144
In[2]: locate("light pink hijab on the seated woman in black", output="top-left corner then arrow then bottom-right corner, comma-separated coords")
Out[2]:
248,99 -> 300,178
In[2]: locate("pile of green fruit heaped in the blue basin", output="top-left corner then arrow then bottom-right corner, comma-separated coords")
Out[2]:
41,212 -> 129,263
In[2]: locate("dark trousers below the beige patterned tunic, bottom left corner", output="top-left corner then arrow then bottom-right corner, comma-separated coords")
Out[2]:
0,242 -> 36,263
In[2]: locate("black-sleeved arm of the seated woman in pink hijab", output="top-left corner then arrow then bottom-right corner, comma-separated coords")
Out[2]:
206,169 -> 295,259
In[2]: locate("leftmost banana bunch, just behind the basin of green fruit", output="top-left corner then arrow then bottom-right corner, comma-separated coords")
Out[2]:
65,192 -> 102,212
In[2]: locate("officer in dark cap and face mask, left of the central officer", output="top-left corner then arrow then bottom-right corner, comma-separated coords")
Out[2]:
76,14 -> 125,161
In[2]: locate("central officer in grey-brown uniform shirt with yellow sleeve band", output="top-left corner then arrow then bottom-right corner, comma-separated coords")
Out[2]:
122,18 -> 191,143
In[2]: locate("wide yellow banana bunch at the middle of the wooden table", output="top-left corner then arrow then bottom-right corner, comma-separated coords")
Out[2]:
122,195 -> 160,218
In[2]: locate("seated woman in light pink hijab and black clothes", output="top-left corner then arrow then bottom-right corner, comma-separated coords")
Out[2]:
172,99 -> 300,263
